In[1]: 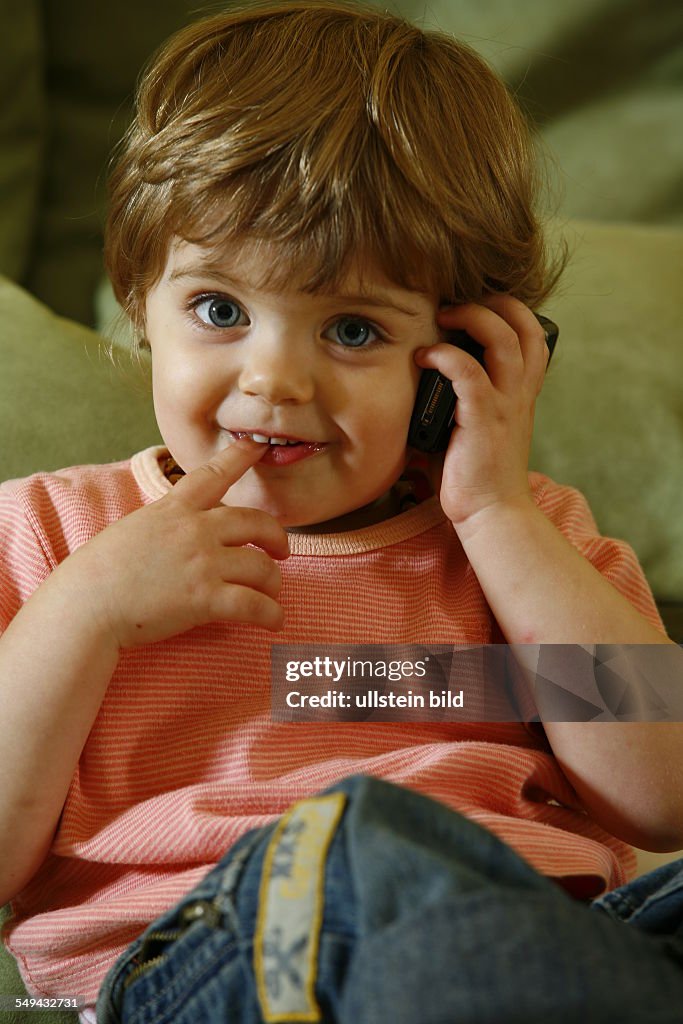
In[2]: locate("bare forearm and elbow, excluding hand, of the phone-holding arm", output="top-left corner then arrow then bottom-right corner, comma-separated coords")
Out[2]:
460,491 -> 683,851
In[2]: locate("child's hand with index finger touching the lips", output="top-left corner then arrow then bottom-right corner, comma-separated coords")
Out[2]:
59,441 -> 289,648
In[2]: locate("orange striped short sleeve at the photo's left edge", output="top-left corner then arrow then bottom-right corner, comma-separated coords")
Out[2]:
0,481 -> 53,633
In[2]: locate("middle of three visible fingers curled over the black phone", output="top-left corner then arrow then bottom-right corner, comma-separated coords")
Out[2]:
437,296 -> 524,391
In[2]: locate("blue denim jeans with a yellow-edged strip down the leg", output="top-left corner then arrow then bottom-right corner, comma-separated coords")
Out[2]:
97,776 -> 683,1024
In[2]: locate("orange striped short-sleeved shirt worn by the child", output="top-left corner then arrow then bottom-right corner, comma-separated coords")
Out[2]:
0,449 -> 661,1001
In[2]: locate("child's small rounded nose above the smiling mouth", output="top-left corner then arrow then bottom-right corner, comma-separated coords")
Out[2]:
238,332 -> 314,406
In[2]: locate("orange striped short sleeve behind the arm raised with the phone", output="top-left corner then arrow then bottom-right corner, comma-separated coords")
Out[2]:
529,473 -> 666,633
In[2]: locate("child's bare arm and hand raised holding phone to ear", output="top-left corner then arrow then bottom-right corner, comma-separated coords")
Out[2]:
418,296 -> 683,850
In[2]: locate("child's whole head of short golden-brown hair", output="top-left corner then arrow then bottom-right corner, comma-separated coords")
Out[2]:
104,0 -> 565,330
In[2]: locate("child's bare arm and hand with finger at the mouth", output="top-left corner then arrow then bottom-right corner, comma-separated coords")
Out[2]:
0,441 -> 288,905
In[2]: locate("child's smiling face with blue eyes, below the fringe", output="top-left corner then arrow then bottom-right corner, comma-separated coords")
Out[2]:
146,243 -> 439,528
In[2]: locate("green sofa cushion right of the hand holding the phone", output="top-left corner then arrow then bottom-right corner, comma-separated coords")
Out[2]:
531,221 -> 683,602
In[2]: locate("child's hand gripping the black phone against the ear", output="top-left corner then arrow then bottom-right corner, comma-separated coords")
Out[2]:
416,295 -> 549,529
